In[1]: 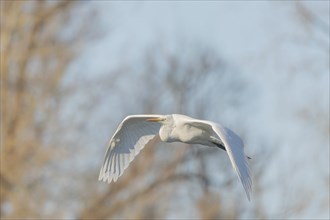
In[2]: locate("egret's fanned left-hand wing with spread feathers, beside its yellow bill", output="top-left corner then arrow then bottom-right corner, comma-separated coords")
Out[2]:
99,115 -> 161,183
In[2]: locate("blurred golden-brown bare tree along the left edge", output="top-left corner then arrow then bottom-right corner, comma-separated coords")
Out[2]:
0,1 -> 95,218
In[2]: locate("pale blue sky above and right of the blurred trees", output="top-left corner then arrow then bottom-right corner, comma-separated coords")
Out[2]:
65,1 -> 329,218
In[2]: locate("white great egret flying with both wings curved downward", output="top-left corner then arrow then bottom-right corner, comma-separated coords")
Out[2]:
99,114 -> 252,200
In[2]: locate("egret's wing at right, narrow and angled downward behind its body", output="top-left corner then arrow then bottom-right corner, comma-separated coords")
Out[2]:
211,123 -> 252,200
